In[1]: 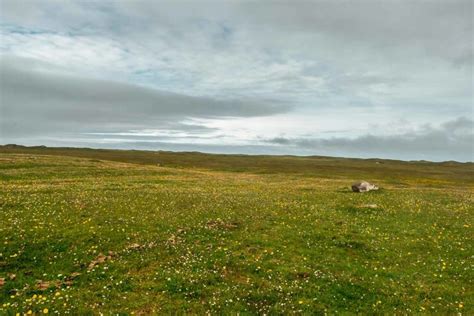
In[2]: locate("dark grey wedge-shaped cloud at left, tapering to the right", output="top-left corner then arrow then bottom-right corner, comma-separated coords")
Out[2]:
0,58 -> 289,138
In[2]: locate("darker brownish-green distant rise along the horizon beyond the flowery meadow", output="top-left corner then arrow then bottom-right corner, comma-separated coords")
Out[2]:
0,144 -> 474,182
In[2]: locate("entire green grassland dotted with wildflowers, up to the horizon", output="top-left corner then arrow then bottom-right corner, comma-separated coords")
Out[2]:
0,146 -> 474,315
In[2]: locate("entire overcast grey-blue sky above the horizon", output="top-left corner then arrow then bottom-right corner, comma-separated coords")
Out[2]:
0,0 -> 474,161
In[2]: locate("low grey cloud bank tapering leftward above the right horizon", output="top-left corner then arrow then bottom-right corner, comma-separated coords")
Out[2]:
265,117 -> 474,161
